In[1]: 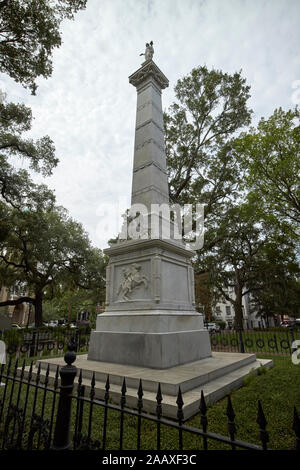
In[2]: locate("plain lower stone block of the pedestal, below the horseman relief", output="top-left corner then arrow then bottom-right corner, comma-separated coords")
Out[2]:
88,309 -> 211,369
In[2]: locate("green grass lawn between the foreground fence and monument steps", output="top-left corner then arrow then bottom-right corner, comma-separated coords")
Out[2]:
0,355 -> 300,450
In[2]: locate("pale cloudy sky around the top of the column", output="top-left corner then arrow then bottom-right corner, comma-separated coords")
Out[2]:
0,0 -> 300,249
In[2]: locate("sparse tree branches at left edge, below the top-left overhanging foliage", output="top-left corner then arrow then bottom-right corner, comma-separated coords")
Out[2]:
0,98 -> 58,229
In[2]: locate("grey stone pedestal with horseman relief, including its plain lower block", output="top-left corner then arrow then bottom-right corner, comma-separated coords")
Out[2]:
88,239 -> 211,369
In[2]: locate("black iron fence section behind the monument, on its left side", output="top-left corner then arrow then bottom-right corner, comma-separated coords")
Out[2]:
0,328 -> 90,358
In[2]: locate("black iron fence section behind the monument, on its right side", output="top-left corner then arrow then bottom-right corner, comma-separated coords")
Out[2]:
210,328 -> 300,356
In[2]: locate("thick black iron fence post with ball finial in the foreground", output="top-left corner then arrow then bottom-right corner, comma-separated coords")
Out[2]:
52,340 -> 77,450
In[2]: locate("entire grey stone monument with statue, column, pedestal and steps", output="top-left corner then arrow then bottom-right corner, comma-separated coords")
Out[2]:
27,45 -> 273,418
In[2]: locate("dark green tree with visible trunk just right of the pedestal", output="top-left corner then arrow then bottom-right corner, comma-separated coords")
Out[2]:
196,203 -> 265,329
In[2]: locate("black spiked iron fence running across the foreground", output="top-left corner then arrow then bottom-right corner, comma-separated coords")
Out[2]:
0,343 -> 300,451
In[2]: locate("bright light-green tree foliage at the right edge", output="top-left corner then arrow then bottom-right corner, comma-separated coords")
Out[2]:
234,107 -> 300,231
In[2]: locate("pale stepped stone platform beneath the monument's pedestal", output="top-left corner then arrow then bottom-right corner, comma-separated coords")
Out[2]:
20,352 -> 273,418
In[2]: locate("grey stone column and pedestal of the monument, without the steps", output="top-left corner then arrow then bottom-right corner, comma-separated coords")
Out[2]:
88,48 -> 211,369
